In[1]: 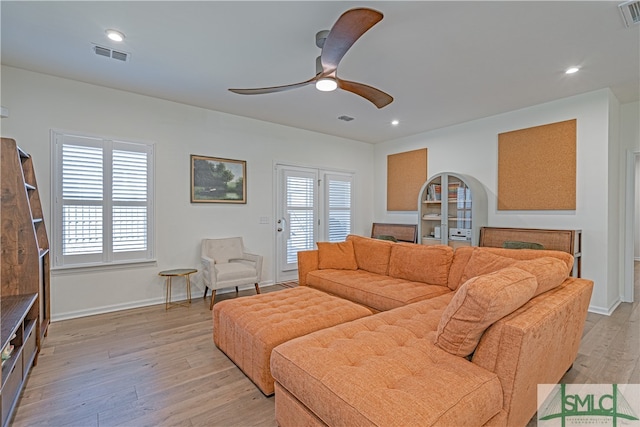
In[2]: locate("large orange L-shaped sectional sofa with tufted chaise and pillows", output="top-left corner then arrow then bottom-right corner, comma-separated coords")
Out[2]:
271,235 -> 593,427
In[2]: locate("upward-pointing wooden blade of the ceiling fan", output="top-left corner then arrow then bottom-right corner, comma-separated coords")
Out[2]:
320,8 -> 383,73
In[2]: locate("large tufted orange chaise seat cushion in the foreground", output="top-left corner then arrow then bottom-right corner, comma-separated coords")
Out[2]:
271,294 -> 503,426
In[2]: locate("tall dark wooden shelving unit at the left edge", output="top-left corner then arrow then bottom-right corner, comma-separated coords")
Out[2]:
0,138 -> 51,426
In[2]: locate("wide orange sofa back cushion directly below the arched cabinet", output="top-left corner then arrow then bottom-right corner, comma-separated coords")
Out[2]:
389,243 -> 453,286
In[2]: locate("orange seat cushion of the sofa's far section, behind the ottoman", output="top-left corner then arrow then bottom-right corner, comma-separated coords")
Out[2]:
306,270 -> 451,311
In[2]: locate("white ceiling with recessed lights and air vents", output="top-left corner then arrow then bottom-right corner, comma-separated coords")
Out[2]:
0,0 -> 640,143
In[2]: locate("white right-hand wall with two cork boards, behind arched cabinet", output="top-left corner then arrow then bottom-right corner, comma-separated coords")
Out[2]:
374,89 -> 619,313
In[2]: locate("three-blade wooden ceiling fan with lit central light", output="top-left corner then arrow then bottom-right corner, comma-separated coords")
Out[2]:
229,8 -> 393,108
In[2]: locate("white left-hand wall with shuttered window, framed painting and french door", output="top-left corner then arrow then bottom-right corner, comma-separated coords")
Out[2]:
1,67 -> 373,320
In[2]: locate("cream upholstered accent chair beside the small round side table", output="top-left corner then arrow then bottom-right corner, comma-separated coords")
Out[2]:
201,237 -> 262,310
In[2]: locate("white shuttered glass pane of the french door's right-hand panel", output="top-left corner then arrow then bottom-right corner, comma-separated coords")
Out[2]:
325,174 -> 352,242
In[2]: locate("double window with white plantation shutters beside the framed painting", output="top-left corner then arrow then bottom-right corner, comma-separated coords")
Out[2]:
51,132 -> 153,267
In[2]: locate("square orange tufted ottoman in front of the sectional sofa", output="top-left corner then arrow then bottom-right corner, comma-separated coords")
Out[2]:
213,286 -> 371,396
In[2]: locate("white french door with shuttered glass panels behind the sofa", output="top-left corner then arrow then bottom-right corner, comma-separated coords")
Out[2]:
276,165 -> 353,283
